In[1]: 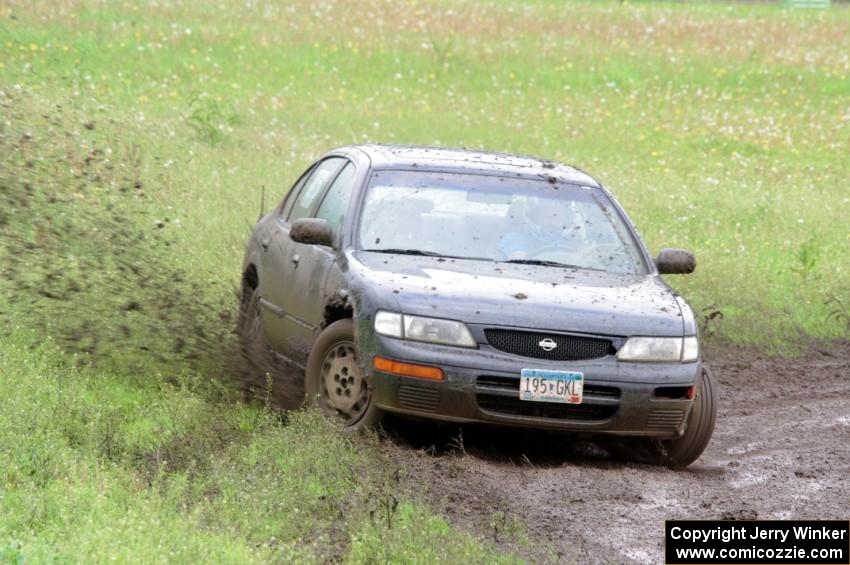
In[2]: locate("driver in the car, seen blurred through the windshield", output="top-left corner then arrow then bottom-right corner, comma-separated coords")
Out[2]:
499,196 -> 566,260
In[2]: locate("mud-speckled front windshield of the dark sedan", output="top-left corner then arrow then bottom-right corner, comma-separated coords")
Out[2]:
358,171 -> 646,274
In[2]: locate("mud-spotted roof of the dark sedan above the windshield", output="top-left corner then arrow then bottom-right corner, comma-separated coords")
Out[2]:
337,144 -> 601,187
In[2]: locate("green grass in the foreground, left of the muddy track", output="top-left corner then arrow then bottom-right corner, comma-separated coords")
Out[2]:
0,333 -> 515,563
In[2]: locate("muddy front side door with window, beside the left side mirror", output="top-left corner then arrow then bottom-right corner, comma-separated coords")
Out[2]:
284,161 -> 357,364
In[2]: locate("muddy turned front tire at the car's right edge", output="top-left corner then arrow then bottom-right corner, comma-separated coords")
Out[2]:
661,368 -> 717,469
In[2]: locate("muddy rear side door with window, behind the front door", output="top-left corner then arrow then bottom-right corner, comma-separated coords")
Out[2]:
259,157 -> 346,366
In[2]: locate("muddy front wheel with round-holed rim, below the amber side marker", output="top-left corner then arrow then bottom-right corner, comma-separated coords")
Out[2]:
305,319 -> 383,431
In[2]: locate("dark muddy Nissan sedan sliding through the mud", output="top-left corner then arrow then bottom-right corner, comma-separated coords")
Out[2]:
239,145 -> 716,466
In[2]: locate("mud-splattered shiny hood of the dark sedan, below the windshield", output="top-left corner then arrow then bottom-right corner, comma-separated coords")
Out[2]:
348,251 -> 684,336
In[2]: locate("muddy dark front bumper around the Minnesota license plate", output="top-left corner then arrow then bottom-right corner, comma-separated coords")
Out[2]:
363,336 -> 701,438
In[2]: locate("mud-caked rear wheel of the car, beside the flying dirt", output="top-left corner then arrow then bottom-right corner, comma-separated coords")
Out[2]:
236,286 -> 296,408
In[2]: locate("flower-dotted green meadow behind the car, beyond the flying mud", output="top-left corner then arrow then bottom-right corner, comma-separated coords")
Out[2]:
6,1 -> 850,349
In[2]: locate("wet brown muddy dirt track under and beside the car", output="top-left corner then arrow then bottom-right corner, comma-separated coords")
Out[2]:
387,343 -> 850,563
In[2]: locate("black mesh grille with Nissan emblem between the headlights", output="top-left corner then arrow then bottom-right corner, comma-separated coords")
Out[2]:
484,328 -> 616,361
